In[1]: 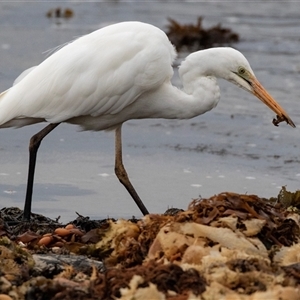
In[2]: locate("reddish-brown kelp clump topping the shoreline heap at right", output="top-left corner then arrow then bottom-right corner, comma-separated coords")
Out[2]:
185,193 -> 300,249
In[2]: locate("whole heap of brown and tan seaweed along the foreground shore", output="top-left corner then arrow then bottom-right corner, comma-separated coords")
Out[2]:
0,188 -> 300,300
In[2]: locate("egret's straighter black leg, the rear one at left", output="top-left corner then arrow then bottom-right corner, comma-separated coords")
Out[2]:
23,123 -> 60,221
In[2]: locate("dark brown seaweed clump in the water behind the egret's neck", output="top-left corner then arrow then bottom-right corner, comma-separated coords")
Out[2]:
167,17 -> 239,51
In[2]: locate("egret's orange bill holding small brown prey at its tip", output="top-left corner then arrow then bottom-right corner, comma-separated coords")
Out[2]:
251,77 -> 296,127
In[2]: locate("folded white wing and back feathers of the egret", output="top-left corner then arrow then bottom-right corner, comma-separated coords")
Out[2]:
0,22 -> 175,128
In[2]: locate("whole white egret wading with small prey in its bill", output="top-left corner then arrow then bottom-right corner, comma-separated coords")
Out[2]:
0,22 -> 295,220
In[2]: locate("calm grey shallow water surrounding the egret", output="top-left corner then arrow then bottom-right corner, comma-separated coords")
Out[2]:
0,1 -> 300,221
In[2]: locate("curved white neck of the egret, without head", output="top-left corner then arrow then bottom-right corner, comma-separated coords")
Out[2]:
135,51 -> 220,119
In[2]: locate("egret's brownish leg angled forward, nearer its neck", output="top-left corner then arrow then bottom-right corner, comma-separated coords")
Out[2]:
115,126 -> 149,215
